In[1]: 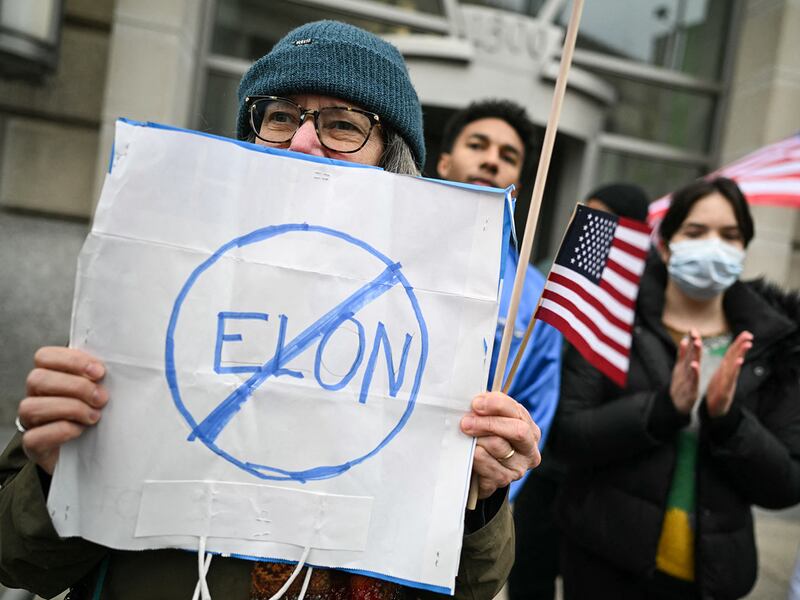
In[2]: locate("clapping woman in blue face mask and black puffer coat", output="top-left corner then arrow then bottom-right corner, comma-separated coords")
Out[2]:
555,178 -> 800,600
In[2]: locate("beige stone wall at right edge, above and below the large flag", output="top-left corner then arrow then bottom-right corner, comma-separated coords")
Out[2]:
721,0 -> 800,288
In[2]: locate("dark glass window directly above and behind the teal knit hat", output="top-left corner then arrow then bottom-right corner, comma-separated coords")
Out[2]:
211,0 -> 439,60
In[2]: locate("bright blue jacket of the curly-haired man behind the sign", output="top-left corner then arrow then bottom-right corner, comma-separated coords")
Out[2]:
489,248 -> 562,500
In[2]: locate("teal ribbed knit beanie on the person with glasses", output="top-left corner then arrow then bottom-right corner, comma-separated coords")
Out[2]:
236,21 -> 425,168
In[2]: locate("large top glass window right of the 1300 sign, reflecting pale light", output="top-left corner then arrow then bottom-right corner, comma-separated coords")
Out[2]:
559,0 -> 733,80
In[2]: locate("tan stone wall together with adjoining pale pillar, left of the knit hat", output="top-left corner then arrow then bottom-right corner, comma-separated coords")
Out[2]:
0,0 -> 206,218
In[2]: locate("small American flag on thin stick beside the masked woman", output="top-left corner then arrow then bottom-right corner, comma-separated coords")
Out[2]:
536,204 -> 650,387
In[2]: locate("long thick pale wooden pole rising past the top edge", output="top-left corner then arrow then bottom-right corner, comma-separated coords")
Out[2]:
467,0 -> 583,510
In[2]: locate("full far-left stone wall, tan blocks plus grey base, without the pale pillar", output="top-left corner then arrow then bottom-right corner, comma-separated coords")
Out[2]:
0,0 -> 114,426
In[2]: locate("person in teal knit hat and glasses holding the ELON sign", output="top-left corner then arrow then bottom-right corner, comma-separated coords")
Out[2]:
0,21 -> 540,600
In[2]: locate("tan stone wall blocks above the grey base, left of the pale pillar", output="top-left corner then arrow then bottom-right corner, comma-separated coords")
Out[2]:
0,0 -> 113,218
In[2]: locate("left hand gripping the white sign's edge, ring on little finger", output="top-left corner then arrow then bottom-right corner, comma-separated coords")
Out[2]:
17,347 -> 108,475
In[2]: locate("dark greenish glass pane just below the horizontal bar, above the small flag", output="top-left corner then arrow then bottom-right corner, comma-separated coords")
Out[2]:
602,76 -> 715,153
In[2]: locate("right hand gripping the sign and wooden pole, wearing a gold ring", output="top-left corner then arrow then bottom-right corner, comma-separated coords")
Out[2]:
461,392 -> 542,498
